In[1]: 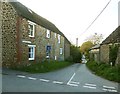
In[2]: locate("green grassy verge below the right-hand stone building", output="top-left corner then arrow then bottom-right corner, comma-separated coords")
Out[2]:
87,61 -> 120,83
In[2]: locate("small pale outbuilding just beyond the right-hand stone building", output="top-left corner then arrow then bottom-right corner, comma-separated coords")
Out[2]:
89,44 -> 100,62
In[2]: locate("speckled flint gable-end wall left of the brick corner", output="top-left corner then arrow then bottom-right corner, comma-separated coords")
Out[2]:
2,2 -> 17,67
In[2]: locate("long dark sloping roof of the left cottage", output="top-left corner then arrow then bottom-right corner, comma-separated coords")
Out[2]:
10,1 -> 70,43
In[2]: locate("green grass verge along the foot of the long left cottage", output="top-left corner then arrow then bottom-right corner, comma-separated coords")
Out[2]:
12,61 -> 73,73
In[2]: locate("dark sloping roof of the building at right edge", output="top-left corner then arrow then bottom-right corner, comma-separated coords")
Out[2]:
102,26 -> 120,44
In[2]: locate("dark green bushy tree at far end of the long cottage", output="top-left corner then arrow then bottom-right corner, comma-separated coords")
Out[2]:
70,45 -> 82,62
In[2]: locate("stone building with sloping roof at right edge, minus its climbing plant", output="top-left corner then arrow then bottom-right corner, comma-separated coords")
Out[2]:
100,26 -> 120,64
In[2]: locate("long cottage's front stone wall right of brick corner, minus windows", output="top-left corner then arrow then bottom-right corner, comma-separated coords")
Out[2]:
19,17 -> 64,64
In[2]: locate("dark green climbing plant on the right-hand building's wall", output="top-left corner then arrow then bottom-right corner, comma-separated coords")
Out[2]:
109,44 -> 118,66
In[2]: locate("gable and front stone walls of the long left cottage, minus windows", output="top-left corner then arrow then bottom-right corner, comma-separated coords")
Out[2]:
0,3 -> 65,67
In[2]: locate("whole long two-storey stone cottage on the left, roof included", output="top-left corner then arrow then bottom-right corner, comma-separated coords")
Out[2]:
0,2 -> 70,67
